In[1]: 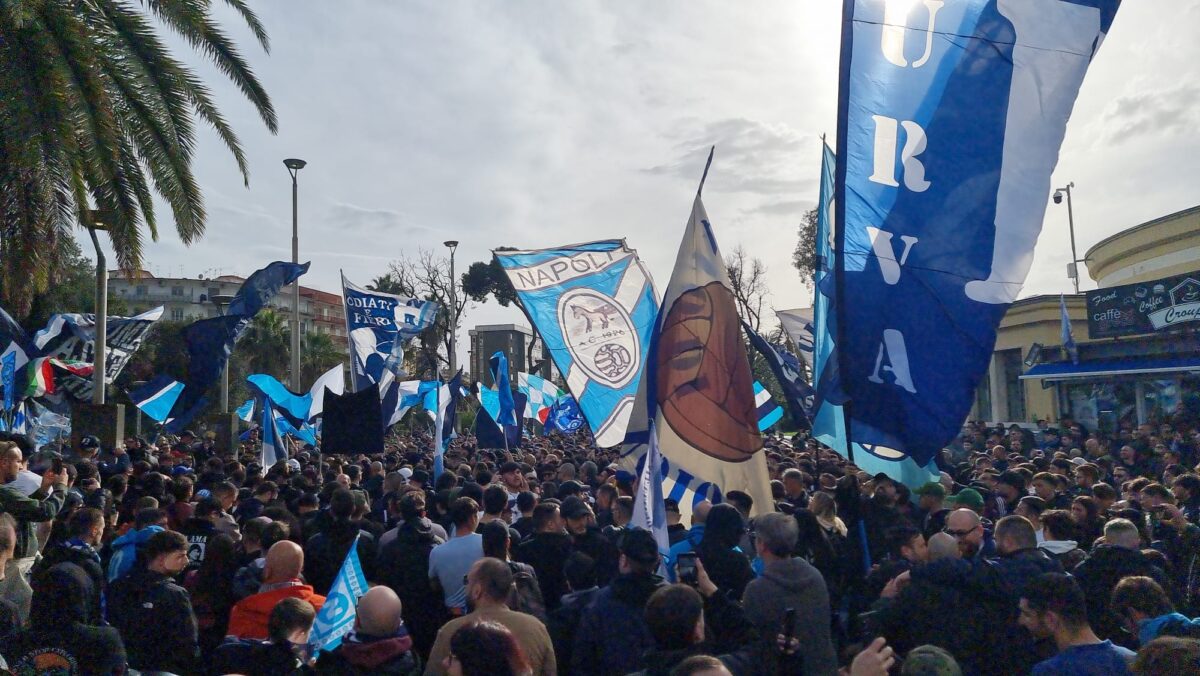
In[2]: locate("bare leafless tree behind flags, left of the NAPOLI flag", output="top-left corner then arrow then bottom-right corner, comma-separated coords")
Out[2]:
371,249 -> 469,378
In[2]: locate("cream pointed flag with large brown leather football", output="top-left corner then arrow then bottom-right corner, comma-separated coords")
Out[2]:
646,177 -> 773,512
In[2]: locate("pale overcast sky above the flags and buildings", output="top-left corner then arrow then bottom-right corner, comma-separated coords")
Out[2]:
87,0 -> 1200,360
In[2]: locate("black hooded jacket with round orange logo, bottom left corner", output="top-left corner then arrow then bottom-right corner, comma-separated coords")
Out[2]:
0,563 -> 126,675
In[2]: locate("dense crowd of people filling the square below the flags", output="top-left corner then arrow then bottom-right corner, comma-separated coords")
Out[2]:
0,420 -> 1200,676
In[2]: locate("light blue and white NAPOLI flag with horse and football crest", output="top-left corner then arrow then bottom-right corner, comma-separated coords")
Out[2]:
493,239 -> 659,448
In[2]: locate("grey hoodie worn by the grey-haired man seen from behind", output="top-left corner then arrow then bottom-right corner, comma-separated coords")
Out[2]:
742,558 -> 838,676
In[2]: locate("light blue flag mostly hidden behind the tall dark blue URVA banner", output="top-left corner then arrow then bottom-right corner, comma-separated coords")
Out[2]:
793,145 -> 938,489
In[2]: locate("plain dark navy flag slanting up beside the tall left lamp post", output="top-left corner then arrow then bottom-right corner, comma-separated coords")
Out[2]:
167,261 -> 308,433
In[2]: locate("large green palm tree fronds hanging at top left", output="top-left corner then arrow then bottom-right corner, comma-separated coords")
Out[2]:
0,0 -> 277,313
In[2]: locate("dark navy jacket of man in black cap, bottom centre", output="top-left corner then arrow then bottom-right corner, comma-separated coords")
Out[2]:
564,573 -> 666,676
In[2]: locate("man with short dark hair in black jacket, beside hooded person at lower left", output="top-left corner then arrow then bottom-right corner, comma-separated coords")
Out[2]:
108,531 -> 200,674
